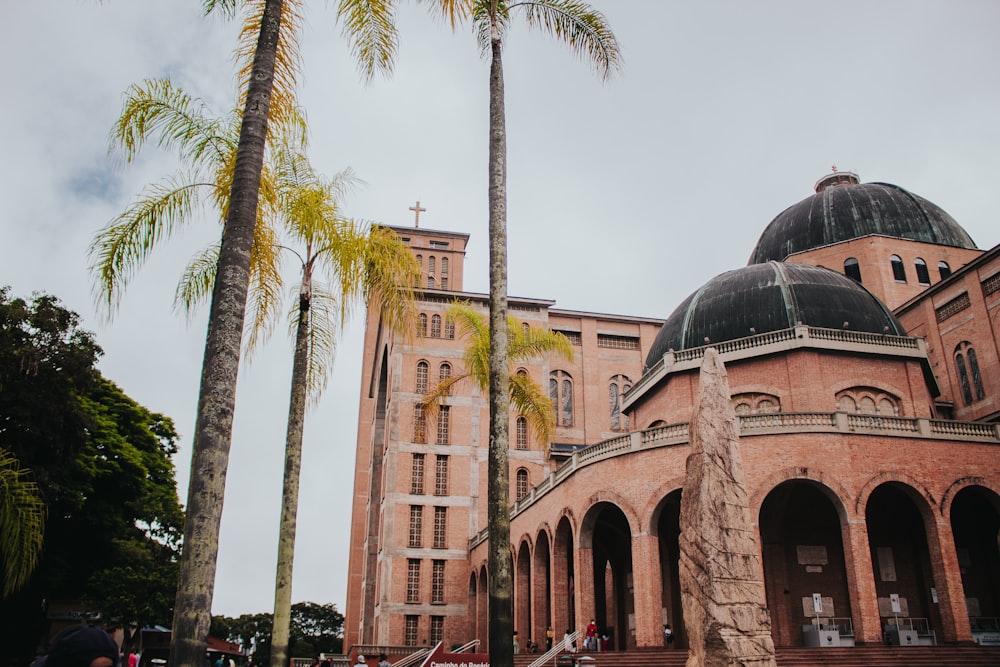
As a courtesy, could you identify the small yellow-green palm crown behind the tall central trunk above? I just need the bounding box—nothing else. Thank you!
[418,302,573,443]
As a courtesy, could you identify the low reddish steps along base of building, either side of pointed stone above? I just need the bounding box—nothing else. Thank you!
[514,645,1000,667]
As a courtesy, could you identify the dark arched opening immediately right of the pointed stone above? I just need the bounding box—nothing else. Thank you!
[759,480,853,646]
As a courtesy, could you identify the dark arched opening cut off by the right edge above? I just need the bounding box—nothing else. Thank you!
[951,486,1000,637]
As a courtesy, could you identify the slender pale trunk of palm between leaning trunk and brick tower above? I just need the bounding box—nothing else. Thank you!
[271,276,311,667]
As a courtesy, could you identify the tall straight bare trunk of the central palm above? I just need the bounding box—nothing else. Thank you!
[486,31,514,667]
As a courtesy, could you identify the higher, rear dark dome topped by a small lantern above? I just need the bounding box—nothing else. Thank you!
[749,172,976,264]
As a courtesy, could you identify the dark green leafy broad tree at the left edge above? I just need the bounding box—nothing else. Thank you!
[0,289,183,664]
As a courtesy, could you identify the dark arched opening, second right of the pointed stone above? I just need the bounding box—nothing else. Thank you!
[865,482,941,643]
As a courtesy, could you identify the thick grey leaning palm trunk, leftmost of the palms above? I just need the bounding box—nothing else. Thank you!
[170,0,283,667]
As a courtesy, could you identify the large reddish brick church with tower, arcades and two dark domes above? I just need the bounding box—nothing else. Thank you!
[345,172,1000,650]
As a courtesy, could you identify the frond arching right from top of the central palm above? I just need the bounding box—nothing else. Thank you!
[510,0,621,81]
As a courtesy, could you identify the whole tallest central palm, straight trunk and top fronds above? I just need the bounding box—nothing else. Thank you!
[454,0,620,667]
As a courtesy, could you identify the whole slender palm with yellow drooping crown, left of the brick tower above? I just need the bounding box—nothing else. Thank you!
[262,149,420,667]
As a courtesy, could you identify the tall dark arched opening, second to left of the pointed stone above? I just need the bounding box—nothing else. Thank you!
[587,503,635,651]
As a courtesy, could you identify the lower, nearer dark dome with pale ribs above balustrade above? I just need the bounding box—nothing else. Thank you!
[646,262,906,368]
